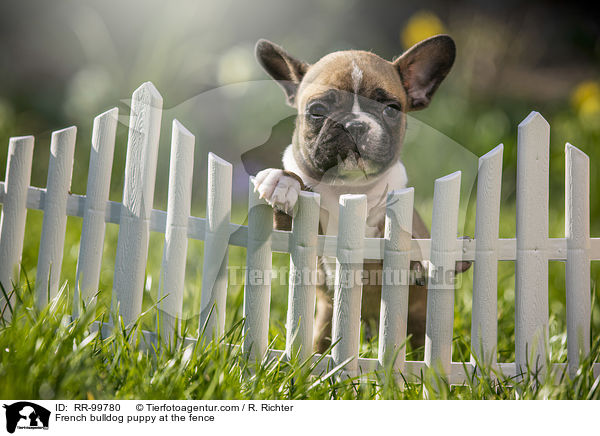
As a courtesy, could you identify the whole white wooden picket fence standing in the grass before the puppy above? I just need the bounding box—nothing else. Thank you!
[0,82,600,384]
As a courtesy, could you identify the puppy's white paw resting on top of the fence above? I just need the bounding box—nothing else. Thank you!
[253,168,302,216]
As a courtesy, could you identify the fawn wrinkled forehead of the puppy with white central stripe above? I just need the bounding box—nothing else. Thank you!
[298,51,406,107]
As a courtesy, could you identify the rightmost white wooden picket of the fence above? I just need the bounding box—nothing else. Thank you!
[565,143,591,377]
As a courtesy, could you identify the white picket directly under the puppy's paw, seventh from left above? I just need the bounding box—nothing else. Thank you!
[242,177,273,361]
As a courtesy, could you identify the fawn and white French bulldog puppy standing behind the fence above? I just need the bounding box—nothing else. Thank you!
[254,35,468,352]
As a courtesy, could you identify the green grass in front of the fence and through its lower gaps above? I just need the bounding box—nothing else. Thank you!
[0,200,600,399]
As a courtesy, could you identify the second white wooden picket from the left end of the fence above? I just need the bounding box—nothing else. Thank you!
[35,127,77,309]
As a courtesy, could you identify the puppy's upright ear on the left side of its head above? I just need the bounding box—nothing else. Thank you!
[255,39,309,106]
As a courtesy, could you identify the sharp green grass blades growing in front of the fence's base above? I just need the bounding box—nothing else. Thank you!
[0,266,600,399]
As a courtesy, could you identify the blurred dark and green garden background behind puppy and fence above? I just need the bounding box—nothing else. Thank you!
[0,0,600,358]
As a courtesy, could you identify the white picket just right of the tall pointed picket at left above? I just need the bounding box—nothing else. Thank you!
[157,120,195,342]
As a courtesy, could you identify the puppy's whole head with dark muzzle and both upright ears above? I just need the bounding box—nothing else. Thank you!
[256,35,456,183]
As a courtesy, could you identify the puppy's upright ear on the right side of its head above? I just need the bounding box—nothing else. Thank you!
[394,35,456,110]
